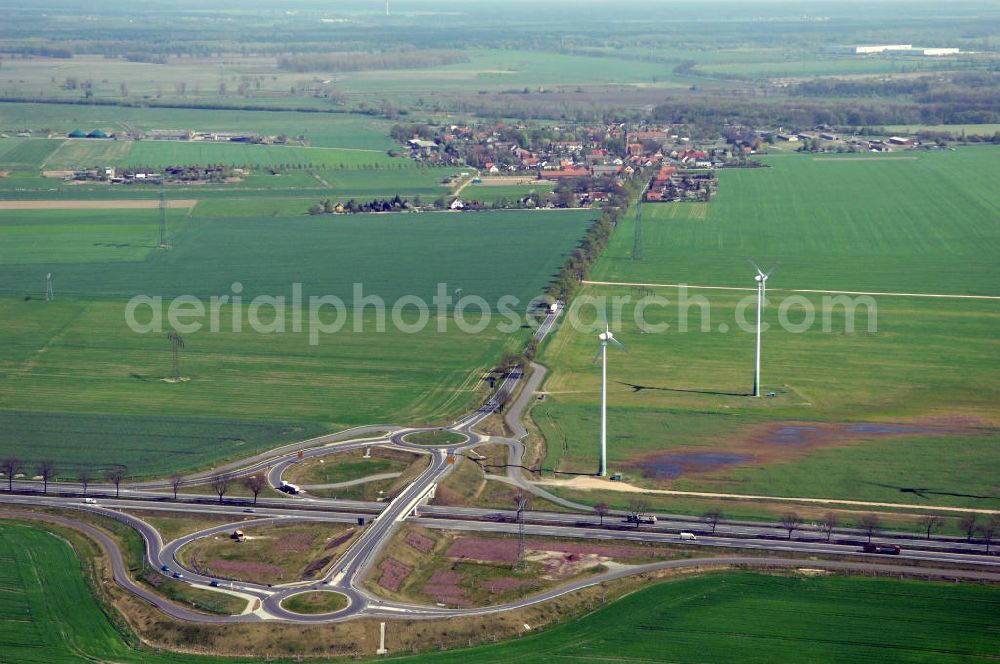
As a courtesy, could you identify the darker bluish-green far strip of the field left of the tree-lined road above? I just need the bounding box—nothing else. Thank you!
[0,210,593,303]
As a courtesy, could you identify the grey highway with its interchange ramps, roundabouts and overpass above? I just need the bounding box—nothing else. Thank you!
[0,309,1000,623]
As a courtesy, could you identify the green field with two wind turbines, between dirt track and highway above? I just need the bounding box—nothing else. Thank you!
[534,287,1000,507]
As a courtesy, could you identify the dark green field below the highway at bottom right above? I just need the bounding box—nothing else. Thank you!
[400,573,1000,663]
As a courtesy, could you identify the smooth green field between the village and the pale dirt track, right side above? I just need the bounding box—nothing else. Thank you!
[590,146,1000,295]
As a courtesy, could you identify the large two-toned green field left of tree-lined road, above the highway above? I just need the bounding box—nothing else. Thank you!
[0,210,590,476]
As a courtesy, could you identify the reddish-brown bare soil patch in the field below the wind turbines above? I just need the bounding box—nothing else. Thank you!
[632,418,981,480]
